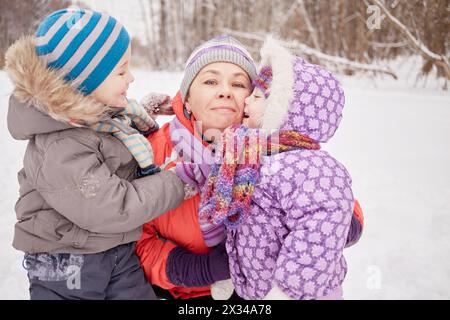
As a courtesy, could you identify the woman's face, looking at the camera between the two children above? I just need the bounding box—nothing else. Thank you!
[186,62,252,137]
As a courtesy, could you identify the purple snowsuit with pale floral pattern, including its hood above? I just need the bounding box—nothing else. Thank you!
[227,44,354,299]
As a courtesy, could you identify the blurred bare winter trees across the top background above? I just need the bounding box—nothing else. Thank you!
[0,0,450,84]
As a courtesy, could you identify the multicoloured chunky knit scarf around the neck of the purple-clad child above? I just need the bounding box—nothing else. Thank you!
[199,125,320,229]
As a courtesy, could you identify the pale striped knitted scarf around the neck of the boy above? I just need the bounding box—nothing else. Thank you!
[90,100,159,174]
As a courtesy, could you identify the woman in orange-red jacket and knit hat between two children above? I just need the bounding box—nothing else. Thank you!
[136,36,256,299]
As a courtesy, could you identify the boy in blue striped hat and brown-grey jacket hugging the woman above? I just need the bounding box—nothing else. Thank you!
[6,8,184,299]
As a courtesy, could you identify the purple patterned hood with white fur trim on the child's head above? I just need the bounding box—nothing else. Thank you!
[260,38,345,142]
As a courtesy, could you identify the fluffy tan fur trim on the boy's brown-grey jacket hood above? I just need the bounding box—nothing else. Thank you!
[5,36,110,126]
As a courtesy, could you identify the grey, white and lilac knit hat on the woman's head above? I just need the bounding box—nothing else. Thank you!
[180,35,256,101]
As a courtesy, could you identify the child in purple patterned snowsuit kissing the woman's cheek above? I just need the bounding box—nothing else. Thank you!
[200,40,355,300]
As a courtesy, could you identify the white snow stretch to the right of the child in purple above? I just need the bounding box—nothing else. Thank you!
[327,75,450,299]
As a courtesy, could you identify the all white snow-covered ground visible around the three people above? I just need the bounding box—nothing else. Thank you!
[0,65,450,299]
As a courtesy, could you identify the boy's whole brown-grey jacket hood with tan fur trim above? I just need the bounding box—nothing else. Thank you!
[5,36,110,139]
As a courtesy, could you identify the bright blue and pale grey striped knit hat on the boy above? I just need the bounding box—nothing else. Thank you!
[35,8,130,95]
